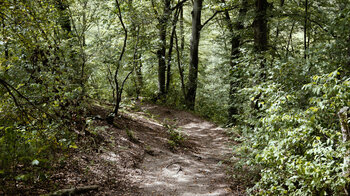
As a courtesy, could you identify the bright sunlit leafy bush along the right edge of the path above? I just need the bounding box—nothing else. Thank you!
[238,70,350,195]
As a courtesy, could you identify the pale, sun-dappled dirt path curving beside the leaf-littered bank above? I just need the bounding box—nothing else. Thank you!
[129,105,239,196]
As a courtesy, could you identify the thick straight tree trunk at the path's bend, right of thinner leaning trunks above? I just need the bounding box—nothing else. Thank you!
[185,0,203,110]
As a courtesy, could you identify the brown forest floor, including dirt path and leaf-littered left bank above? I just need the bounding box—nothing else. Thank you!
[4,100,245,196]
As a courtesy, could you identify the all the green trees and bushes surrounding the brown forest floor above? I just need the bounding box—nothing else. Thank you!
[0,0,350,195]
